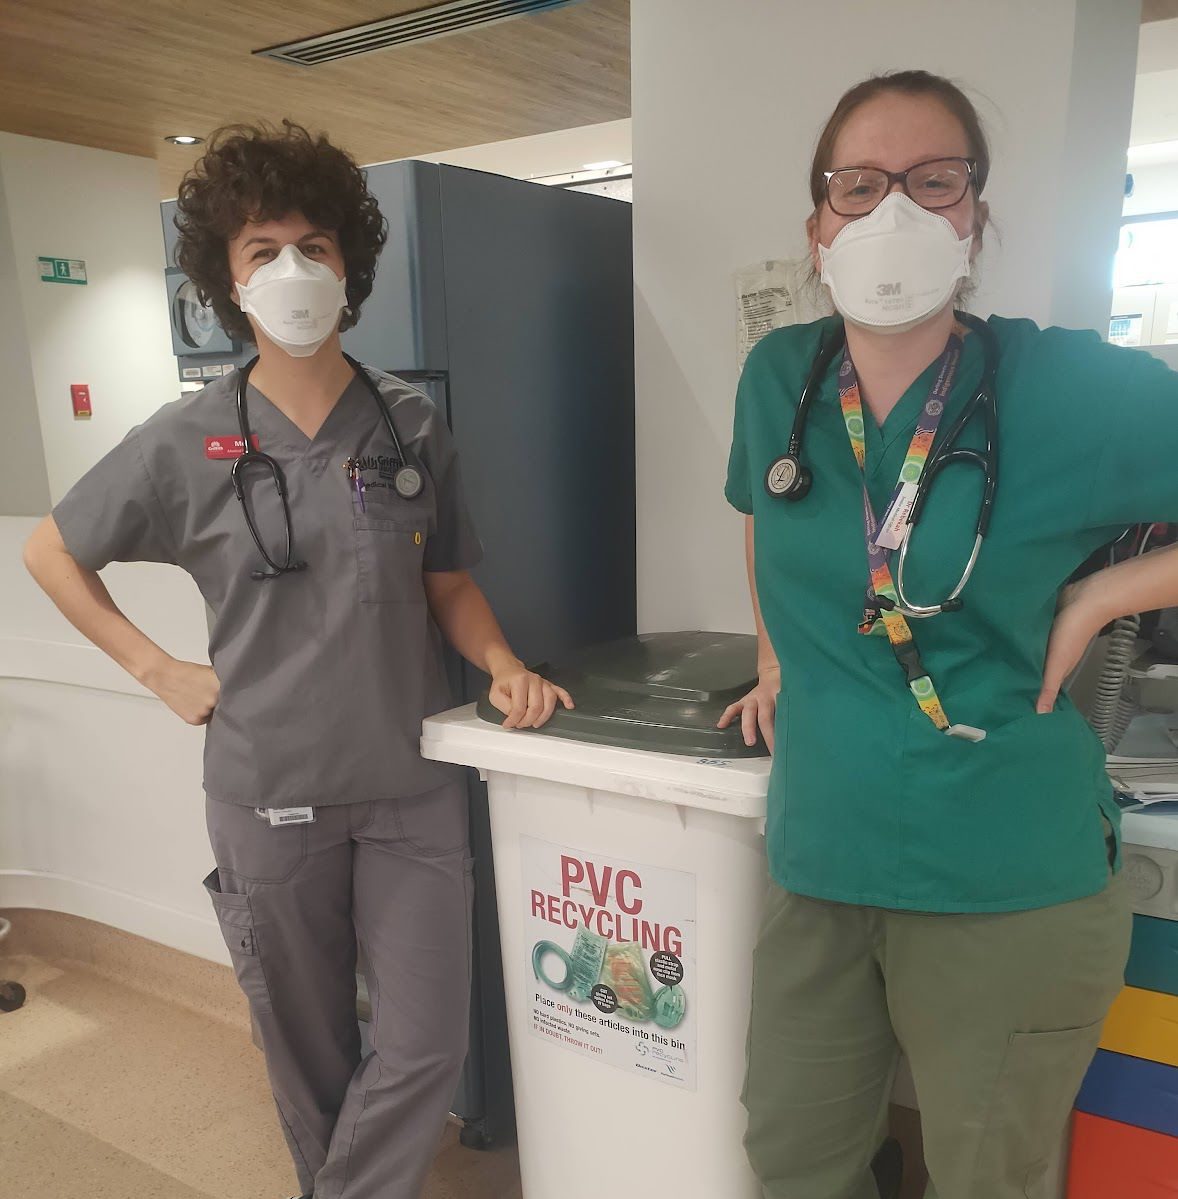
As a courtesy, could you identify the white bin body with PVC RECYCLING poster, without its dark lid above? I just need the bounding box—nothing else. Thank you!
[422,642,769,1199]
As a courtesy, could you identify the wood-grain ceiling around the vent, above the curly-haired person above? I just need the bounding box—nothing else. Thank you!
[0,0,630,197]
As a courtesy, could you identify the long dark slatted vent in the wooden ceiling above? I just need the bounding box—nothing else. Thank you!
[260,0,587,67]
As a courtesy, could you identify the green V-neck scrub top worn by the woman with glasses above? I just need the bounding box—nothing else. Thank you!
[726,318,1178,912]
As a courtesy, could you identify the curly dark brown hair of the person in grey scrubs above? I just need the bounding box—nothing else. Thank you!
[175,120,389,342]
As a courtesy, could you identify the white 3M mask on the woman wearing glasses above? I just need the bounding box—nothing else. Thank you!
[818,192,973,333]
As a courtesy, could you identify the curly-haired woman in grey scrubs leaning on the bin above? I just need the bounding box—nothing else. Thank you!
[25,122,571,1199]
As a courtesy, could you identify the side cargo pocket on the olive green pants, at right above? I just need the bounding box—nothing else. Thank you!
[981,1019,1104,1199]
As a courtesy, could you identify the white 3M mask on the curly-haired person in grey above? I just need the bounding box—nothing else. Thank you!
[238,245,348,359]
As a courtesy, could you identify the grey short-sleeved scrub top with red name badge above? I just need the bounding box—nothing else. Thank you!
[53,370,482,807]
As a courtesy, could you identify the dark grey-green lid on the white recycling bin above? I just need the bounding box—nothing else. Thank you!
[479,632,769,758]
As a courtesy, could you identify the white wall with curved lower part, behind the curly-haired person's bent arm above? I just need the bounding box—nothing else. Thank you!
[0,133,217,960]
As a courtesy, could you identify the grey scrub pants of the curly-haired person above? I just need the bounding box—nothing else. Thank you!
[205,784,473,1199]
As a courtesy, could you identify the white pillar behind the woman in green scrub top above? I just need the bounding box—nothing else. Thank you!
[631,0,1138,629]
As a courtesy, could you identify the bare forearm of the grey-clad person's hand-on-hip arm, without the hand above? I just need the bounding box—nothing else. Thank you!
[24,517,168,683]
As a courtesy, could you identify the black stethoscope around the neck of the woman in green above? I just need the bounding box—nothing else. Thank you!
[765,312,998,619]
